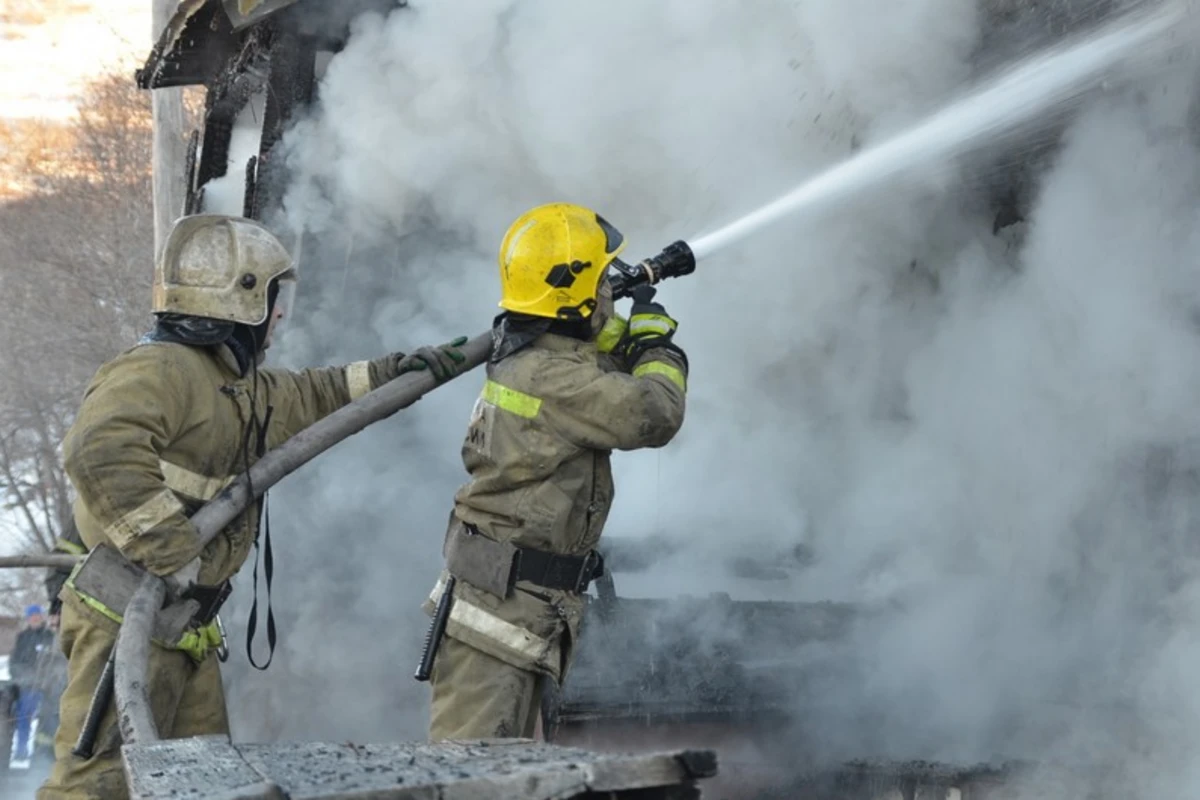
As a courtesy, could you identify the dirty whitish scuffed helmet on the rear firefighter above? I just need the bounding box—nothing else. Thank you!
[151,213,294,325]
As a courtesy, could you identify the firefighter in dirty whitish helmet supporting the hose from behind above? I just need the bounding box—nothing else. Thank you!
[37,215,464,800]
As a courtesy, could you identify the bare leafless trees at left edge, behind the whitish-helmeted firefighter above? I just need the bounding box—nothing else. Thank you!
[0,72,154,609]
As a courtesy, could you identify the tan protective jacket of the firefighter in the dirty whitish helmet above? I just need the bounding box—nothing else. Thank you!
[64,342,398,585]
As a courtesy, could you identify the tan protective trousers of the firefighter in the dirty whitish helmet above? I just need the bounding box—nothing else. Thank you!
[37,589,229,800]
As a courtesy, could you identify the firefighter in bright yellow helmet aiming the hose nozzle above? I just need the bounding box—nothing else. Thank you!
[425,203,688,741]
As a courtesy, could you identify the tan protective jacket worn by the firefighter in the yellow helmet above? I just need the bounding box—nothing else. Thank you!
[425,333,686,680]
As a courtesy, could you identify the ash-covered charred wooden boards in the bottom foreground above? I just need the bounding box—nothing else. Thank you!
[122,736,716,800]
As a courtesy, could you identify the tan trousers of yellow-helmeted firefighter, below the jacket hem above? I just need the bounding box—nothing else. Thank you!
[430,636,546,741]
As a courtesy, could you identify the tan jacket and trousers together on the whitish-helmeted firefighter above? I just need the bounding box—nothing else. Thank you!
[38,339,400,800]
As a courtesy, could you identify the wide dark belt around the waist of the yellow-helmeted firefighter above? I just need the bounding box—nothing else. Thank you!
[443,516,604,597]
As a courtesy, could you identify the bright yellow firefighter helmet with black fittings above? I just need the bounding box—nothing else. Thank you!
[499,203,625,319]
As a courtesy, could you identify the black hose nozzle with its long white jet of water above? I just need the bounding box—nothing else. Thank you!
[610,0,1190,292]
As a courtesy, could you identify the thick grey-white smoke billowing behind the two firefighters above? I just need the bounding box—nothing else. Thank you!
[211,0,1200,796]
